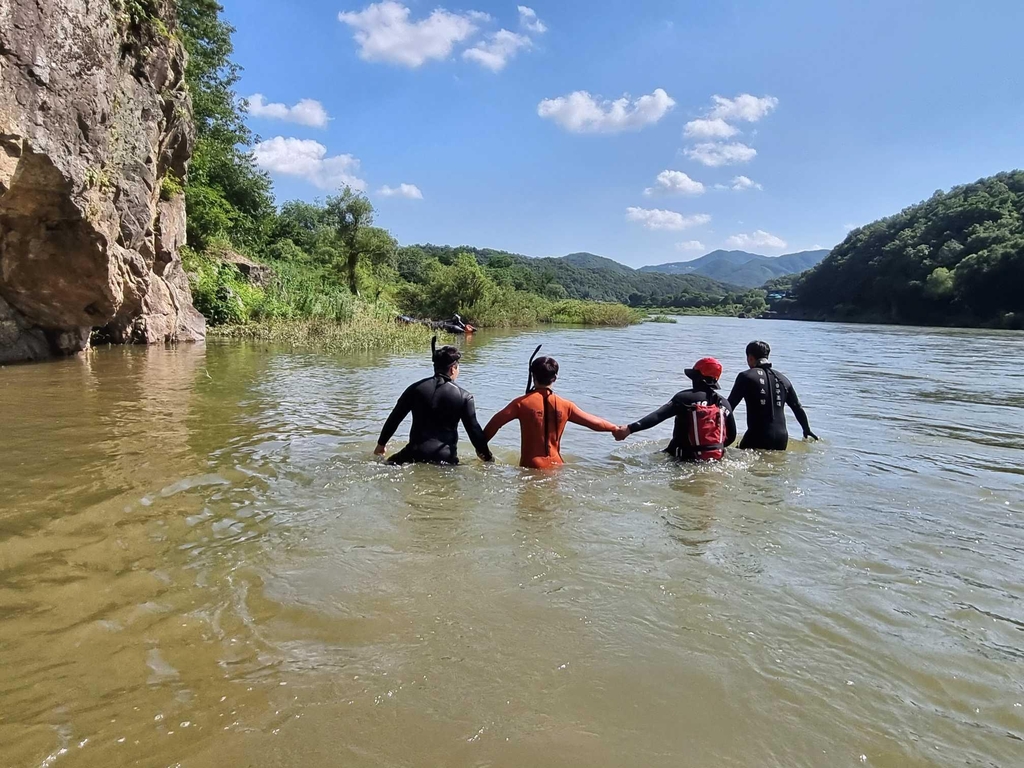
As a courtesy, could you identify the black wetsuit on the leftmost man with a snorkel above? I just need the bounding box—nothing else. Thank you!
[378,374,490,464]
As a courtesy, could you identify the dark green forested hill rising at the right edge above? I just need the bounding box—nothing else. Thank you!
[791,171,1024,328]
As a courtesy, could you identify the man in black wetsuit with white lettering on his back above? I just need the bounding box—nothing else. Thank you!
[729,341,818,451]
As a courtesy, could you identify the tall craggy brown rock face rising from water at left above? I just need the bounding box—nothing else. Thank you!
[0,0,206,362]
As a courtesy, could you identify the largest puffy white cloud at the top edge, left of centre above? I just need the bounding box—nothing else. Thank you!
[338,0,477,68]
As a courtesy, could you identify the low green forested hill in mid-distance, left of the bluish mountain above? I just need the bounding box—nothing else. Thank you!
[399,245,757,307]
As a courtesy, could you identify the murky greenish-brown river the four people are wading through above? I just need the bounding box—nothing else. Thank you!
[0,318,1024,768]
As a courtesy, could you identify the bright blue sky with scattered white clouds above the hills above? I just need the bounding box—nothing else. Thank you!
[222,0,1024,266]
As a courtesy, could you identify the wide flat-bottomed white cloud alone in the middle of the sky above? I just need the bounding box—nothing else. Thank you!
[537,88,676,133]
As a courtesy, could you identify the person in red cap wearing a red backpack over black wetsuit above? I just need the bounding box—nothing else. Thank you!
[614,357,736,461]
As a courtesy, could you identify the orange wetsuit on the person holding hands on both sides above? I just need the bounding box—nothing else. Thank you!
[483,387,615,469]
